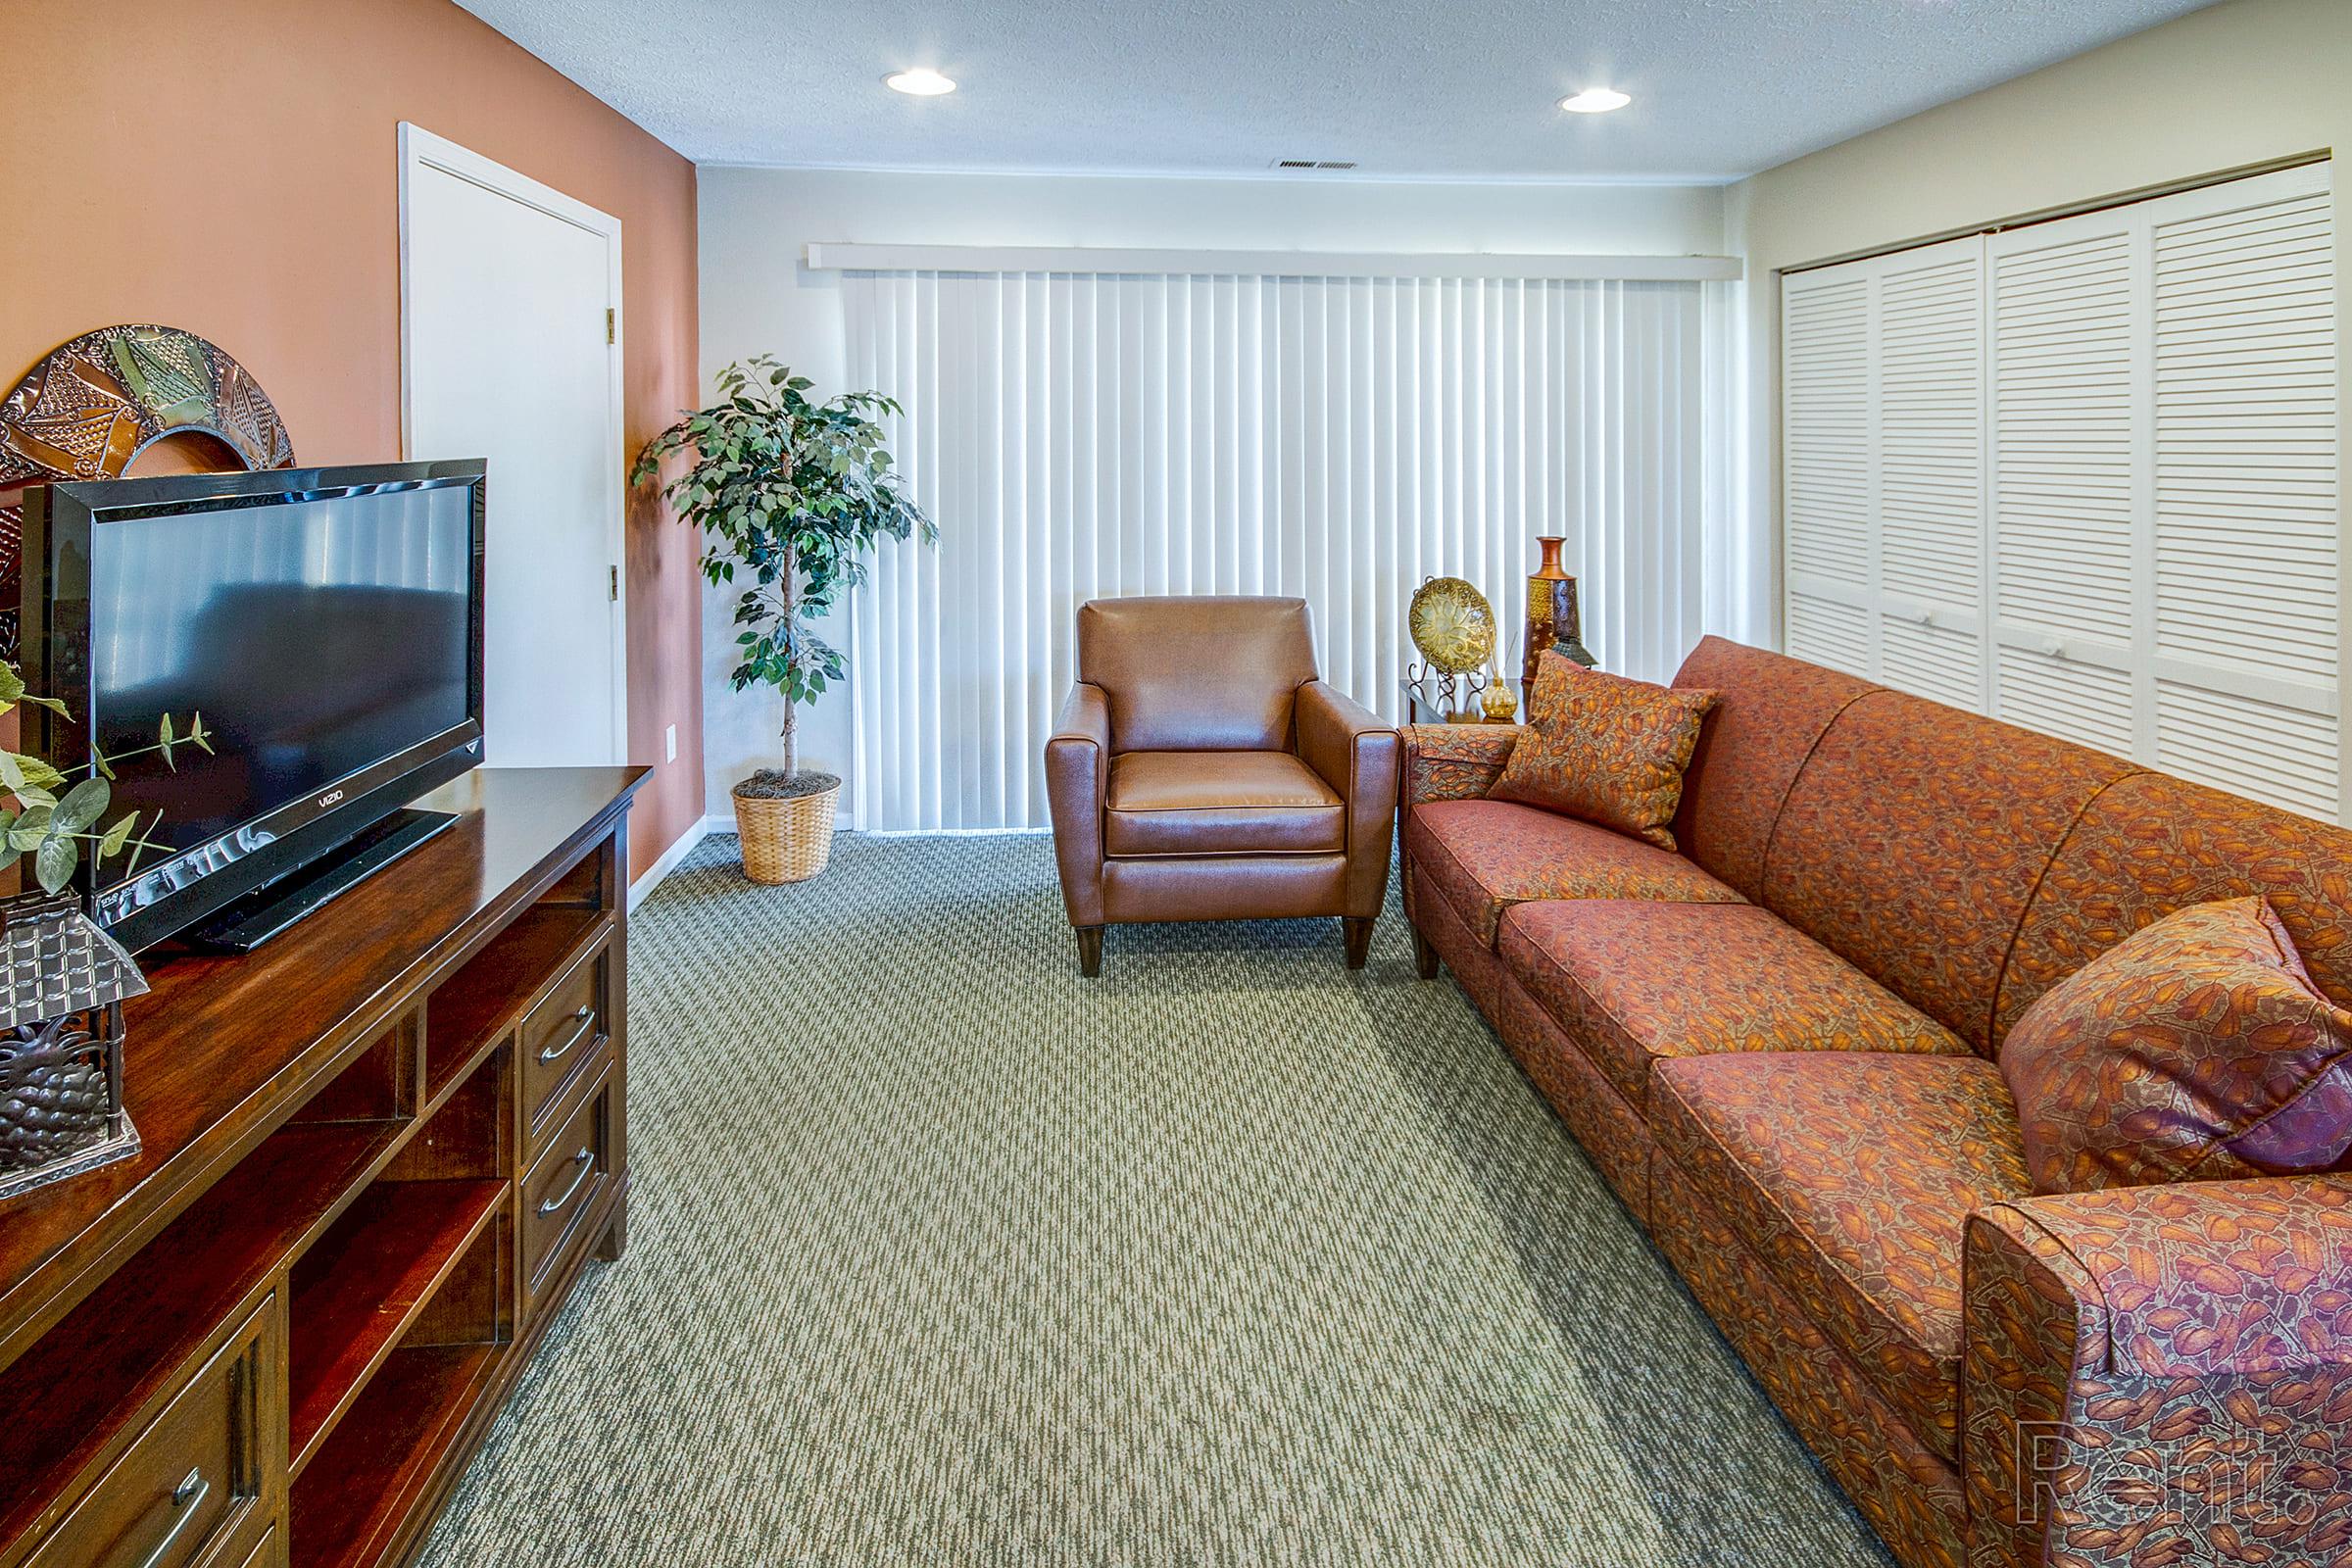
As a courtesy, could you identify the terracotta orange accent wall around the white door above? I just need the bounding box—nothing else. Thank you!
[0,0,704,870]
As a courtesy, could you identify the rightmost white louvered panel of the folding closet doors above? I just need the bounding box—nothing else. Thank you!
[2140,176,2352,820]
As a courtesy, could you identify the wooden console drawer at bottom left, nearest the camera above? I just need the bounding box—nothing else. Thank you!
[25,1296,282,1568]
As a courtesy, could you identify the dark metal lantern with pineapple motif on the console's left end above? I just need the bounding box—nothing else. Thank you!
[0,894,148,1199]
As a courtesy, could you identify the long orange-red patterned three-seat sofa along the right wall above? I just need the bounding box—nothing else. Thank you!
[1401,637,2352,1568]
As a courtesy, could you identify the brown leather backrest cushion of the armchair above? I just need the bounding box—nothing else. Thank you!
[1077,595,1315,753]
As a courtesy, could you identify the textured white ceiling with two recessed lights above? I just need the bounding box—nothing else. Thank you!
[459,0,2211,178]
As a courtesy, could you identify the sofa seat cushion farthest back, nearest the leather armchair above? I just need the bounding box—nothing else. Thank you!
[1404,800,1740,948]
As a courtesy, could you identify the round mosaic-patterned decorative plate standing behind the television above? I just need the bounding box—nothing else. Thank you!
[0,326,294,662]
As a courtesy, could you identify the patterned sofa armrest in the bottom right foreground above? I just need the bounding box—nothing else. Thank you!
[1962,1175,2352,1568]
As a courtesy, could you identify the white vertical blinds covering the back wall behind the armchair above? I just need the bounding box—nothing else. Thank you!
[842,272,1739,830]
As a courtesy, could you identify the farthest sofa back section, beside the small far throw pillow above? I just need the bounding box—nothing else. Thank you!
[1675,637,1880,901]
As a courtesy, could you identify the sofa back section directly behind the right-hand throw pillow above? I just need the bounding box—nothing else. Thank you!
[1994,773,2352,1037]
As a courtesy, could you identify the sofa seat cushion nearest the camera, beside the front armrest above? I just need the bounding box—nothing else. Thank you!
[1648,1051,2033,1462]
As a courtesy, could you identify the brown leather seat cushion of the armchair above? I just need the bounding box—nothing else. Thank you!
[1103,753,1348,856]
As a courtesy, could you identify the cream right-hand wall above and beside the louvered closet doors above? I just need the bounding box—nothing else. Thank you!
[1724,0,2352,649]
